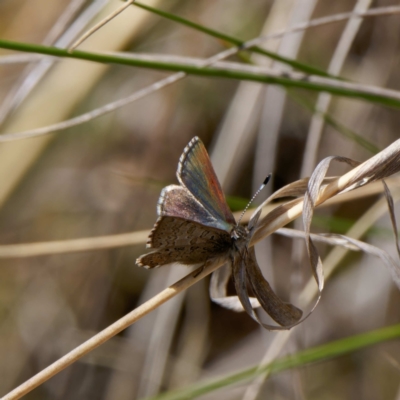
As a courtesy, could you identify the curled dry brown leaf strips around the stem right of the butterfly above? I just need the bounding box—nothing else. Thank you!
[214,141,400,330]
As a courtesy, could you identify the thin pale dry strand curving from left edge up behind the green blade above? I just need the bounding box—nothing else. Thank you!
[0,4,400,142]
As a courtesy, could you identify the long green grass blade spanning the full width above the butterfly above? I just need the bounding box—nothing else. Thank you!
[0,40,400,108]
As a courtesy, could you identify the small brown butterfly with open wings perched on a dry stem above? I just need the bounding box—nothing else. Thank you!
[137,137,248,268]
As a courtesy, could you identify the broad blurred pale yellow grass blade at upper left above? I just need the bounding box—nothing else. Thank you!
[0,0,161,212]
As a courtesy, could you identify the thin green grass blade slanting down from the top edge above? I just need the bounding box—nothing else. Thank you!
[132,2,339,79]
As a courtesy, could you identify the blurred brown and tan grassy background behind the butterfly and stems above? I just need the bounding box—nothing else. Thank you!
[0,0,400,400]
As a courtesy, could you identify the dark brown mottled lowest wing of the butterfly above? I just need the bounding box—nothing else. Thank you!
[137,216,231,268]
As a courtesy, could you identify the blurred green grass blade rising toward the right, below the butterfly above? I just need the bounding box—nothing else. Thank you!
[146,324,400,400]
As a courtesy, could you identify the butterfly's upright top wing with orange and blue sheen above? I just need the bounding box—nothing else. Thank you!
[177,137,236,229]
